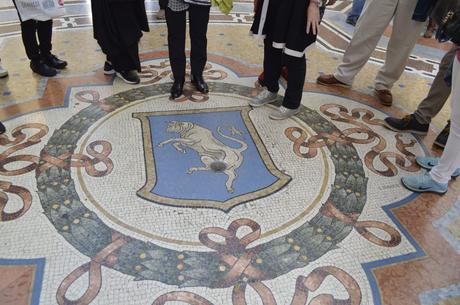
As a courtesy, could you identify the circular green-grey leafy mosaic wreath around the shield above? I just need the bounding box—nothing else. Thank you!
[36,83,367,288]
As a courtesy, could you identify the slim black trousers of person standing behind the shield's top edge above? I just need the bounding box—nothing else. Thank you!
[166,4,210,80]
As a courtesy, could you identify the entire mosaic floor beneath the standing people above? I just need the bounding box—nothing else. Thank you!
[0,0,460,305]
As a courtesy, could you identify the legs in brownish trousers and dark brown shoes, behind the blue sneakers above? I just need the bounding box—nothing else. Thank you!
[385,47,456,148]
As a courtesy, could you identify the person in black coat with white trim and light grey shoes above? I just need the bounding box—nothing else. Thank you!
[249,0,324,120]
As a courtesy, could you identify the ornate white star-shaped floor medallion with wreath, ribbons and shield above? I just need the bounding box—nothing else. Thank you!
[0,54,458,305]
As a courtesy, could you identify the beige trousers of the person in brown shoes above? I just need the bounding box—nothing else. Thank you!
[334,0,424,90]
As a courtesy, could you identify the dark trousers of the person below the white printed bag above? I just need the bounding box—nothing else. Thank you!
[21,20,53,60]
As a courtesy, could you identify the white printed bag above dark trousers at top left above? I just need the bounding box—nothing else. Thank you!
[15,0,66,21]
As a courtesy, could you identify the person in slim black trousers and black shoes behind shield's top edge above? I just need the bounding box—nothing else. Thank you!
[166,0,211,99]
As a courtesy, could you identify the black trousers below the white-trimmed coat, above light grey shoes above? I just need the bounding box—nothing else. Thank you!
[263,39,307,109]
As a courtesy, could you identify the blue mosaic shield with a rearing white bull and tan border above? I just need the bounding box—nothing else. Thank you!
[133,107,291,211]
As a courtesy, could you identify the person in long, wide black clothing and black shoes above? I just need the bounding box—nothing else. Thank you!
[91,0,149,84]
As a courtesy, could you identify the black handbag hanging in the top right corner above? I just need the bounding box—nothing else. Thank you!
[431,0,460,45]
